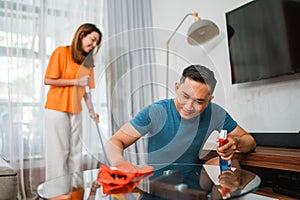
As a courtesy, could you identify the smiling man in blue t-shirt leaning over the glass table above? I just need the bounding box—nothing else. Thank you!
[106,65,256,173]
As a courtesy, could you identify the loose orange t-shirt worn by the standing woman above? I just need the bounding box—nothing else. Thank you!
[45,46,95,114]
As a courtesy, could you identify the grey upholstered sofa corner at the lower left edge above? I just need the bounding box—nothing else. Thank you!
[0,156,18,200]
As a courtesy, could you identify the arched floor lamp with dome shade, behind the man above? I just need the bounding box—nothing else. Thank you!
[166,12,220,98]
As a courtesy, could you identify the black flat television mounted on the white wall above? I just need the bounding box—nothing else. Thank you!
[226,0,300,84]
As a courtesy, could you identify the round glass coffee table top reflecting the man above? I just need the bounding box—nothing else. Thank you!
[37,163,261,200]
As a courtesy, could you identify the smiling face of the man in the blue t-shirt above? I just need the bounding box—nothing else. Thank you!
[175,78,213,119]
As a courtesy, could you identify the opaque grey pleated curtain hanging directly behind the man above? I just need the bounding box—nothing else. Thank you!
[104,0,158,164]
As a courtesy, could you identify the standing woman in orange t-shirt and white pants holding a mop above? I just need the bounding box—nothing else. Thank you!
[44,23,102,180]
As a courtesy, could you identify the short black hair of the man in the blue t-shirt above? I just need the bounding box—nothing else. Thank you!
[180,65,217,95]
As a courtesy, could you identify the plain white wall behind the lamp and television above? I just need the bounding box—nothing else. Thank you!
[152,0,300,132]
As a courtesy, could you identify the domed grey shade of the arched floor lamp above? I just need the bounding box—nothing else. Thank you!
[187,19,220,45]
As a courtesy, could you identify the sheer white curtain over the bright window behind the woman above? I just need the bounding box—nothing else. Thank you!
[0,0,103,199]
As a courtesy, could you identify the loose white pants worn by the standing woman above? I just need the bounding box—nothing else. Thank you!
[45,109,82,180]
